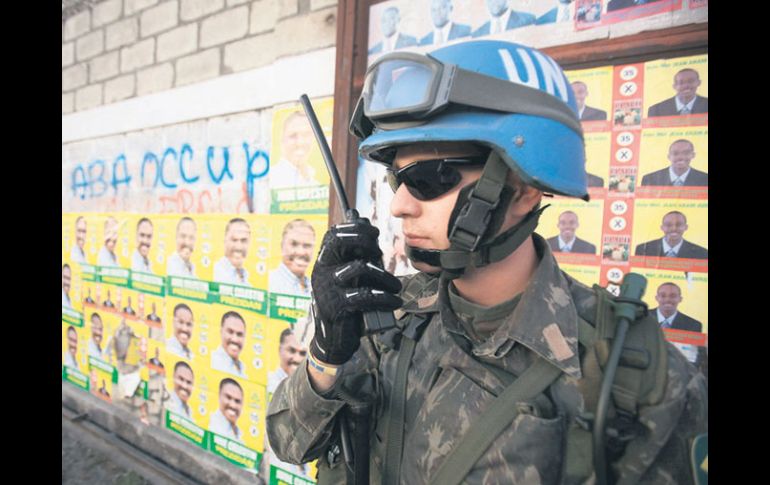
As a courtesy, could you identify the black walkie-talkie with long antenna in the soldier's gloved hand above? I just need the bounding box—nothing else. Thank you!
[299,94,396,335]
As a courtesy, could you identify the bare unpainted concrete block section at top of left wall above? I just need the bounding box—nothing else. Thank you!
[62,0,337,114]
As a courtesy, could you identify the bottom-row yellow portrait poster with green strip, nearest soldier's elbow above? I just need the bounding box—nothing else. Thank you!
[204,370,267,473]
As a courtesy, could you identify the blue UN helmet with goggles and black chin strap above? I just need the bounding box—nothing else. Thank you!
[350,41,588,276]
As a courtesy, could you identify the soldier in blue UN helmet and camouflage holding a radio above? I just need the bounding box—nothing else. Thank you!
[267,41,707,484]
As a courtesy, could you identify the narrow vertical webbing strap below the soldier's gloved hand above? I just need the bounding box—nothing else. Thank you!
[382,334,417,485]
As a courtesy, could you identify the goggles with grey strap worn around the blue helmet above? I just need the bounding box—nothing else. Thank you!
[350,52,583,139]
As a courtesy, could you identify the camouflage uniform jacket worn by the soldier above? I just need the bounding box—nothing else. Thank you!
[267,234,708,485]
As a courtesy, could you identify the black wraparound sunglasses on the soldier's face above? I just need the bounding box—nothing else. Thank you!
[387,155,487,200]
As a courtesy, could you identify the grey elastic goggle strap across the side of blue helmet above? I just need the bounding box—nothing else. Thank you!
[449,68,583,138]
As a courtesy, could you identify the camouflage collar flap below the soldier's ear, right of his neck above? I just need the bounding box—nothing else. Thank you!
[441,233,581,378]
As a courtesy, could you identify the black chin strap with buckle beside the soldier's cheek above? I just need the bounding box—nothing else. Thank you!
[442,150,509,251]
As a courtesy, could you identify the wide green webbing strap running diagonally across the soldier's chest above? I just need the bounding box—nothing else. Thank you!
[430,357,561,485]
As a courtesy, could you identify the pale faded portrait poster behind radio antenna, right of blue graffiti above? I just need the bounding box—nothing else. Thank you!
[268,97,334,214]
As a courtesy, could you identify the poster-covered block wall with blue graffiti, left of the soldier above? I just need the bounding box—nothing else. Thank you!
[61,0,336,483]
